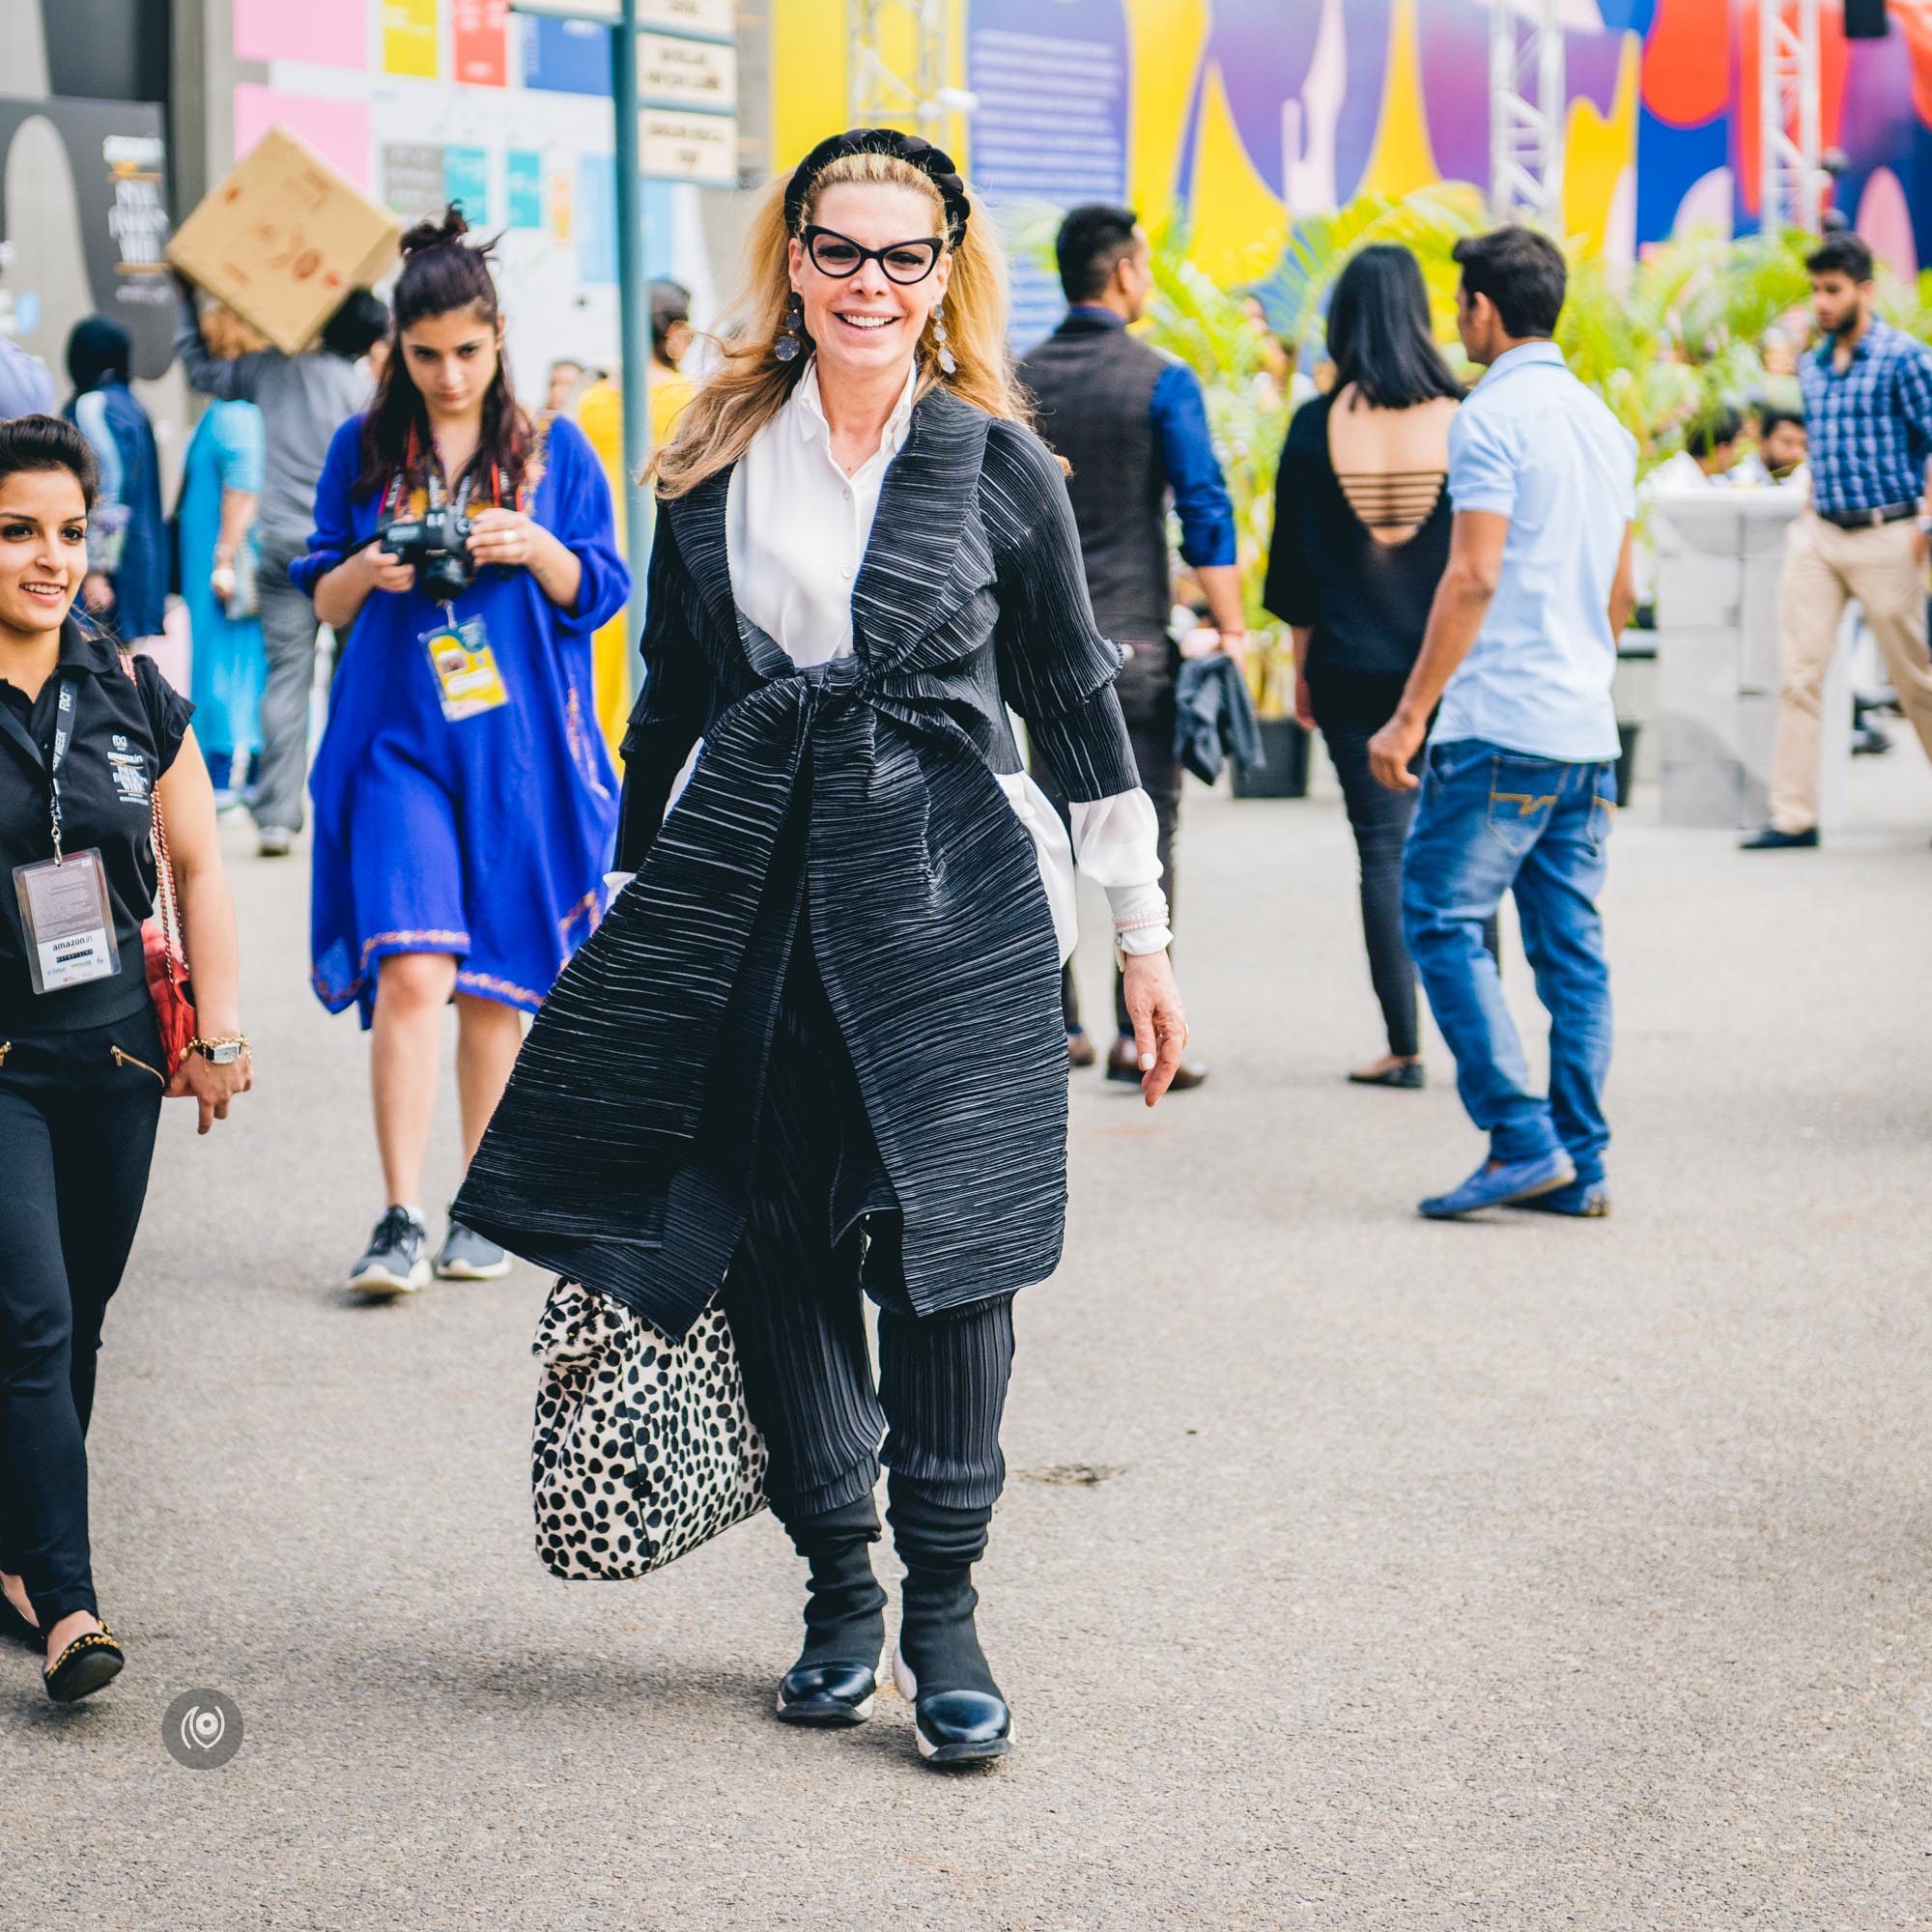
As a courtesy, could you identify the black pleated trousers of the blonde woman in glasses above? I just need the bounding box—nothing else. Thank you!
[724,943,1012,1526]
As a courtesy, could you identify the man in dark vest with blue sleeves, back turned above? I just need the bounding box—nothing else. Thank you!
[1020,205,1246,1092]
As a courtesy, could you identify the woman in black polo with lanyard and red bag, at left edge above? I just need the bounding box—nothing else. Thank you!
[0,415,249,1704]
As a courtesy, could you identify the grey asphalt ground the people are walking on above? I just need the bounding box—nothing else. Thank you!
[0,732,1932,1932]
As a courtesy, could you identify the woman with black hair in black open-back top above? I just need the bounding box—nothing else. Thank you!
[1264,243,1463,1088]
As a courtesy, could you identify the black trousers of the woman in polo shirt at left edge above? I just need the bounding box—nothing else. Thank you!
[0,1007,162,1629]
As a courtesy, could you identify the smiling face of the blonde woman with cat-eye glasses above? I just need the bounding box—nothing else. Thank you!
[790,182,952,377]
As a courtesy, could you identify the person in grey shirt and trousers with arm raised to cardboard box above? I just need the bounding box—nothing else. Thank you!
[174,280,388,858]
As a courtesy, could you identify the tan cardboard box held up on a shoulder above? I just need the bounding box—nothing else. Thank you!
[168,128,402,355]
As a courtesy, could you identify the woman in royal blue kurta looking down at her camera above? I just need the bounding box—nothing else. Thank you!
[290,209,630,1294]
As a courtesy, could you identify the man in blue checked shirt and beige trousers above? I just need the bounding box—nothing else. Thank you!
[1745,232,1932,852]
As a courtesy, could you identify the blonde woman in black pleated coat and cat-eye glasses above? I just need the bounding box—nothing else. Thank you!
[458,128,1186,1766]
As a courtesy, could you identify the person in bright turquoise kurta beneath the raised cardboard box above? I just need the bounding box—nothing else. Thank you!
[180,388,269,804]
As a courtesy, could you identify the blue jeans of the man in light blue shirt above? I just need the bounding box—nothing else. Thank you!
[1403,738,1617,1180]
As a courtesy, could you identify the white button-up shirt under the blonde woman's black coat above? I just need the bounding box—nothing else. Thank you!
[724,357,1171,960]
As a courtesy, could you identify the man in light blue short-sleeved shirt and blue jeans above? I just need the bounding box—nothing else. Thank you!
[1370,228,1636,1219]
